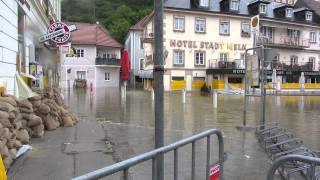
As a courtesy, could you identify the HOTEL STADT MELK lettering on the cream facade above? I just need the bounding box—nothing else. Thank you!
[170,40,247,51]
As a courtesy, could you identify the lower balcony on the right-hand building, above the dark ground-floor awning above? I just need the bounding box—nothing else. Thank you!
[271,62,316,71]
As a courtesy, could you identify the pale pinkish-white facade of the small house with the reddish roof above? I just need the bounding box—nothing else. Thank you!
[60,45,121,88]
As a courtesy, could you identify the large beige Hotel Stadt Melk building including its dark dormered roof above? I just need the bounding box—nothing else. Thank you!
[143,0,320,91]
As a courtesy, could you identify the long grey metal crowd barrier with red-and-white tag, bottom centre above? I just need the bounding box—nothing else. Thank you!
[72,129,224,180]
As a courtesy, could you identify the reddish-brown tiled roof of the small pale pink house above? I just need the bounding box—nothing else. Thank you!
[67,22,122,48]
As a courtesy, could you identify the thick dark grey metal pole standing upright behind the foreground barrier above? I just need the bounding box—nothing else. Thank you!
[153,0,164,180]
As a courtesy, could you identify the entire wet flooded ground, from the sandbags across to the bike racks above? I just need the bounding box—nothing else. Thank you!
[9,89,320,180]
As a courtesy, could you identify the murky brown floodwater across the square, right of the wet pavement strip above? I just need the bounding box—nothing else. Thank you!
[65,89,320,180]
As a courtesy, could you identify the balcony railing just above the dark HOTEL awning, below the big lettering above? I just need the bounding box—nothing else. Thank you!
[209,59,244,69]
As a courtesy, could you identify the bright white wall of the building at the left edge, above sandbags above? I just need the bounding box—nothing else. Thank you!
[0,0,18,94]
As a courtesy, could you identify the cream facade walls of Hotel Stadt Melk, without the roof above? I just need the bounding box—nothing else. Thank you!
[144,4,320,91]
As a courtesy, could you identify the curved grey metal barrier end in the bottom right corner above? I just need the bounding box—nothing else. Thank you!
[267,154,320,180]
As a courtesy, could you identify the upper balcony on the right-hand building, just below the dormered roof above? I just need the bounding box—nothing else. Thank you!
[257,36,310,49]
